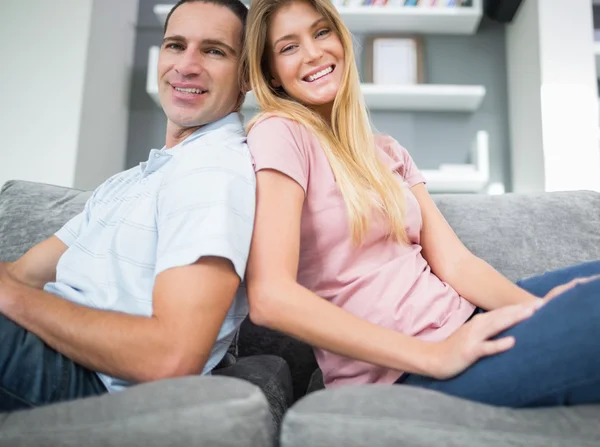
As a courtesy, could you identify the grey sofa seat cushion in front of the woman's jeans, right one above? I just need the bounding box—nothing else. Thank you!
[280,385,600,447]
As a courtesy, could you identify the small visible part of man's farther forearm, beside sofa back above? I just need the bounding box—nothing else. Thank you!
[6,236,67,289]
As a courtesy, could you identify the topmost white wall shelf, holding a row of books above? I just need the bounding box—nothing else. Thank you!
[154,0,483,34]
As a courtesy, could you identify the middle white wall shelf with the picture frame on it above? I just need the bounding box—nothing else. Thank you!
[146,46,485,112]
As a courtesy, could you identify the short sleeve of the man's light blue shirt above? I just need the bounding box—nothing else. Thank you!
[155,146,256,281]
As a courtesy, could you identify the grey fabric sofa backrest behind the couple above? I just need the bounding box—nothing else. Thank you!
[0,181,600,398]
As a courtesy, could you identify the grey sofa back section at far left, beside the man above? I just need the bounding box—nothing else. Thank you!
[0,180,91,262]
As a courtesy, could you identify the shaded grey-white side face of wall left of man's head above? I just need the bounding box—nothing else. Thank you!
[74,0,138,189]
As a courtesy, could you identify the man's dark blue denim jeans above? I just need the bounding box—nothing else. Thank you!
[0,315,107,412]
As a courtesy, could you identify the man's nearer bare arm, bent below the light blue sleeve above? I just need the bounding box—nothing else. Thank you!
[0,257,240,382]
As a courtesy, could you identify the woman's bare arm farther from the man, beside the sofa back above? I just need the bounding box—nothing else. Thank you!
[411,183,538,310]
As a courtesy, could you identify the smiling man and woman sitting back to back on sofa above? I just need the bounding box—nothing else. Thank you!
[0,0,600,411]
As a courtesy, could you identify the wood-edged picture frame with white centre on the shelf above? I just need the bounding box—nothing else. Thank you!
[365,34,425,85]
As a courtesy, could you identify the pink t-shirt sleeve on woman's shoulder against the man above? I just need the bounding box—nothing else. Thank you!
[248,117,309,193]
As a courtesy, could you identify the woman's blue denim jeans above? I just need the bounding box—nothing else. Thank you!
[397,261,600,408]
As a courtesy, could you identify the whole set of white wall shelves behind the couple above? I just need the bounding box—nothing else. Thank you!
[146,0,490,193]
